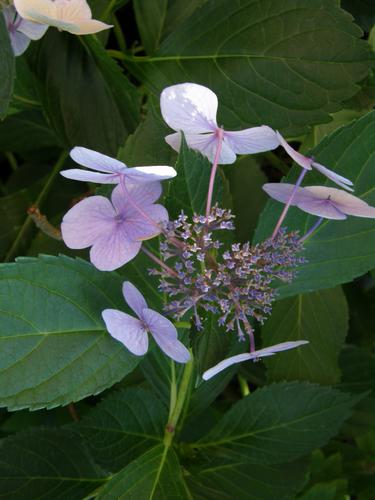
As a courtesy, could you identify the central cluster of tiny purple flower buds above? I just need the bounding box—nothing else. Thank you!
[151,206,305,337]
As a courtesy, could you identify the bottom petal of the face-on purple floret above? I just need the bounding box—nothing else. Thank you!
[90,229,142,271]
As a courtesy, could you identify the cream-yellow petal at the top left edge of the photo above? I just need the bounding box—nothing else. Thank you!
[14,0,112,35]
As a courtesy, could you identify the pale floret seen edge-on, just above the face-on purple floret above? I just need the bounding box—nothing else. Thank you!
[61,146,177,184]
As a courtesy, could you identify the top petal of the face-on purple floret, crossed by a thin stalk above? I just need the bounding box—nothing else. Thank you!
[111,181,162,214]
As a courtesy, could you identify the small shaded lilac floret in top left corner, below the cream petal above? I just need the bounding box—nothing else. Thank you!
[3,6,48,56]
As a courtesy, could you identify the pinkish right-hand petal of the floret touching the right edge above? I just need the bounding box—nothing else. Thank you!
[306,186,375,218]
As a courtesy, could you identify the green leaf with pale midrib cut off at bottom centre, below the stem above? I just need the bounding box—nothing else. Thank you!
[97,445,191,500]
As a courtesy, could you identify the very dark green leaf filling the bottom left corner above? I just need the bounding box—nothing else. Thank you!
[0,429,106,500]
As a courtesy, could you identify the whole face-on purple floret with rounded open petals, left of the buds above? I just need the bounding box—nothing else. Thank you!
[61,182,168,271]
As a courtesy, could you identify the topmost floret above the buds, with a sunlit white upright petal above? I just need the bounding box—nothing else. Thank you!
[160,83,279,164]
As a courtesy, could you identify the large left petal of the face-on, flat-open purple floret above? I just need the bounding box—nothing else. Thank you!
[61,196,116,249]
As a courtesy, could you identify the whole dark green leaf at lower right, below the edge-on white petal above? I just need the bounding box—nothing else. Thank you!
[195,382,360,464]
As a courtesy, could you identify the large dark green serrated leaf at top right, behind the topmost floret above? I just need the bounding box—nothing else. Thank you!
[125,0,375,132]
